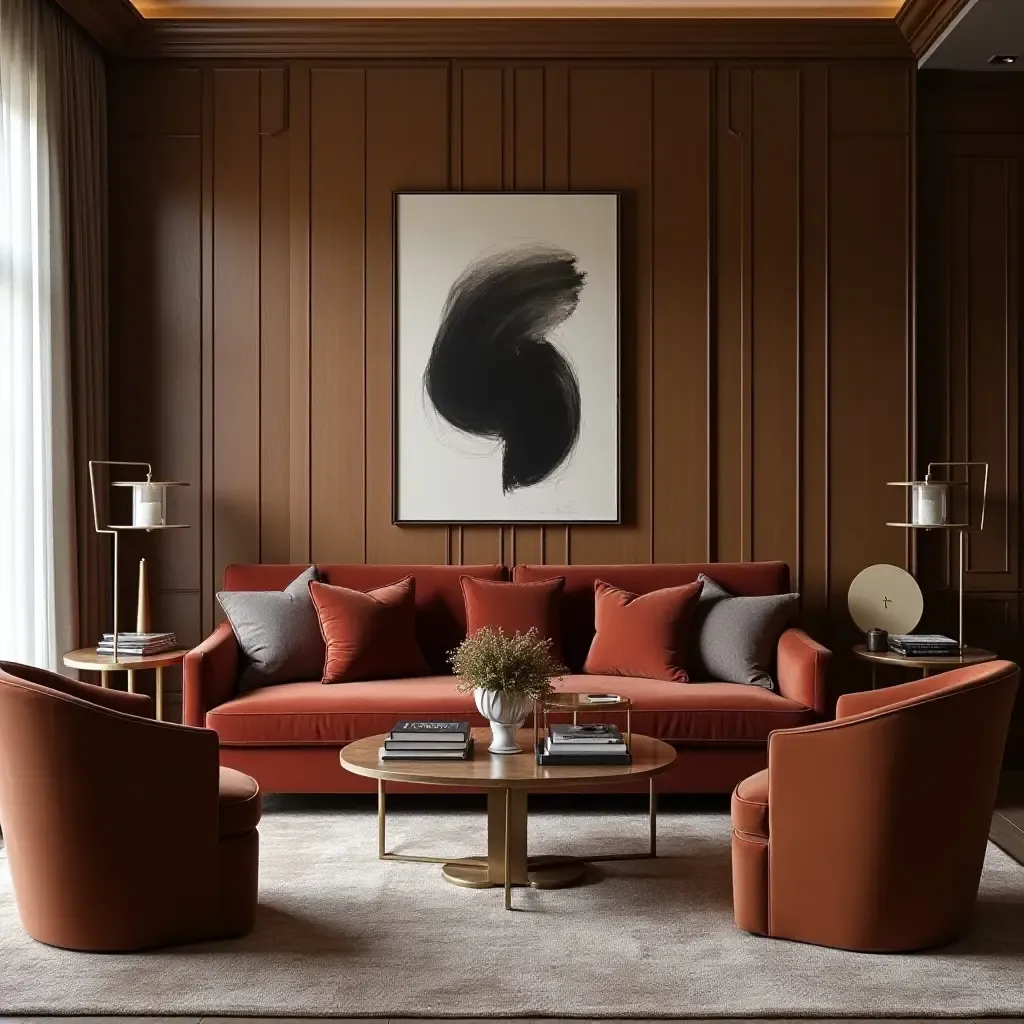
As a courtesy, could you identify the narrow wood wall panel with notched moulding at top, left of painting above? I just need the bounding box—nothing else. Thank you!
[259,69,291,562]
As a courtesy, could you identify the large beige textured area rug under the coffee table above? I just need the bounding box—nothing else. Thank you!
[0,798,1024,1018]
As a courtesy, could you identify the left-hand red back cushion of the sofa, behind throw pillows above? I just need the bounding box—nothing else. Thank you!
[224,563,509,678]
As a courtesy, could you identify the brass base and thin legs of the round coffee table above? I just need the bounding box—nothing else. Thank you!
[377,779,657,910]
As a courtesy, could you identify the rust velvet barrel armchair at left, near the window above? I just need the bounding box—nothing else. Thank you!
[0,662,261,952]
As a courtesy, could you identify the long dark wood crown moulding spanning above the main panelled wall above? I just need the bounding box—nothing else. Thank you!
[130,18,911,60]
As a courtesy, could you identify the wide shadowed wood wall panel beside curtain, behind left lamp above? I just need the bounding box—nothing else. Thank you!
[106,69,204,642]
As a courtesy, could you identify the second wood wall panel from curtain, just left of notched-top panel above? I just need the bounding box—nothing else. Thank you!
[209,69,260,593]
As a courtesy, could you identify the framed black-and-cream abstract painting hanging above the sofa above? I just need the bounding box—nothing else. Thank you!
[392,193,622,524]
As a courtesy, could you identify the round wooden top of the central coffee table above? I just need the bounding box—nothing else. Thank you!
[341,729,676,790]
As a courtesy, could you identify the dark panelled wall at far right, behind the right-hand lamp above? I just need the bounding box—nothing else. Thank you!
[918,73,1024,763]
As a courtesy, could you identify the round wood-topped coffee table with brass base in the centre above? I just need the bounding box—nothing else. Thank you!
[341,729,676,910]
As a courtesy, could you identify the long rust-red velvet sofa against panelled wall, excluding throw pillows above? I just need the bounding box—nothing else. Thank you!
[184,562,829,793]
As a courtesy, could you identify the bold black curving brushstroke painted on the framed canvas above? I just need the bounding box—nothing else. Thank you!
[423,247,587,495]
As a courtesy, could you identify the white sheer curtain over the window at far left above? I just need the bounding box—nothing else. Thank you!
[0,0,77,668]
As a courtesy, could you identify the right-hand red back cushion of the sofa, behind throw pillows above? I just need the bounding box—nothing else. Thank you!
[516,562,790,679]
